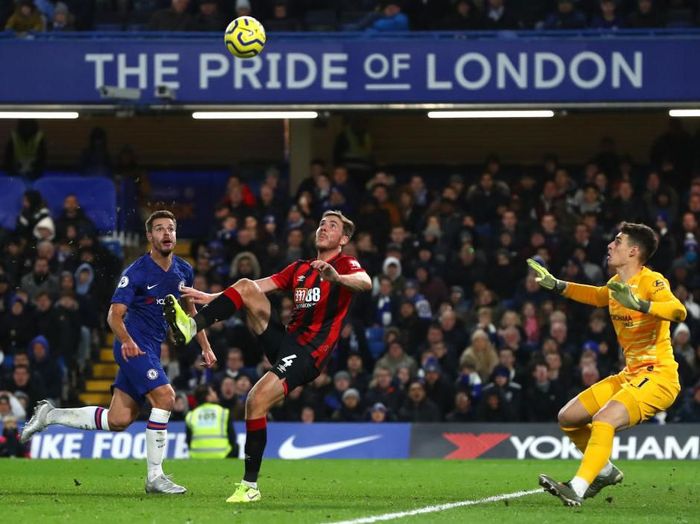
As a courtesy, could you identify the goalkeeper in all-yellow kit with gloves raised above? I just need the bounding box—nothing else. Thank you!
[527,222,686,506]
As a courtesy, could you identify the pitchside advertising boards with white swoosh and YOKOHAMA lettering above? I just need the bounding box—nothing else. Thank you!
[19,422,700,460]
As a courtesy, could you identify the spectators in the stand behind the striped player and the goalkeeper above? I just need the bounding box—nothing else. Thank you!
[178,116,700,422]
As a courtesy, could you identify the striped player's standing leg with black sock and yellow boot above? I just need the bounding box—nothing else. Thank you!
[226,372,285,503]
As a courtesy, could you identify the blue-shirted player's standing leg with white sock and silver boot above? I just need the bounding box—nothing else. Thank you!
[146,384,187,494]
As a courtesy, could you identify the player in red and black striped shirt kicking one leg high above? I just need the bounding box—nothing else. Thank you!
[164,211,372,502]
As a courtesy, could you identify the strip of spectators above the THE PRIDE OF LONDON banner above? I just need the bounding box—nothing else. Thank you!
[0,0,700,34]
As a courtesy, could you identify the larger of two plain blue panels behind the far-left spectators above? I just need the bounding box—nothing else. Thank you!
[34,176,117,233]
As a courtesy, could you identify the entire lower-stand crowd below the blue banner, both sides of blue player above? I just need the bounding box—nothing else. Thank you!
[0,114,700,430]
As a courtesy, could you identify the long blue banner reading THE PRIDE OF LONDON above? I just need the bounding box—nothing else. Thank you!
[0,33,700,105]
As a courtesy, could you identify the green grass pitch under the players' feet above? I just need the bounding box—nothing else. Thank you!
[0,459,700,524]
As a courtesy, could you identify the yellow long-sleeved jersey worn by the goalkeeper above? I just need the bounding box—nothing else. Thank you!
[564,267,686,382]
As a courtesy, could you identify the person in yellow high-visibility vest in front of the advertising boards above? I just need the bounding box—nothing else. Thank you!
[185,384,238,458]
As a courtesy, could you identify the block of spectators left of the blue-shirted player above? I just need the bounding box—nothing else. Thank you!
[0,179,122,434]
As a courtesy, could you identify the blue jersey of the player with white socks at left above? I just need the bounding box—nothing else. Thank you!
[112,254,194,348]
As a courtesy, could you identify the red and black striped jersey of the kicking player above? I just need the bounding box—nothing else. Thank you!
[271,253,364,369]
